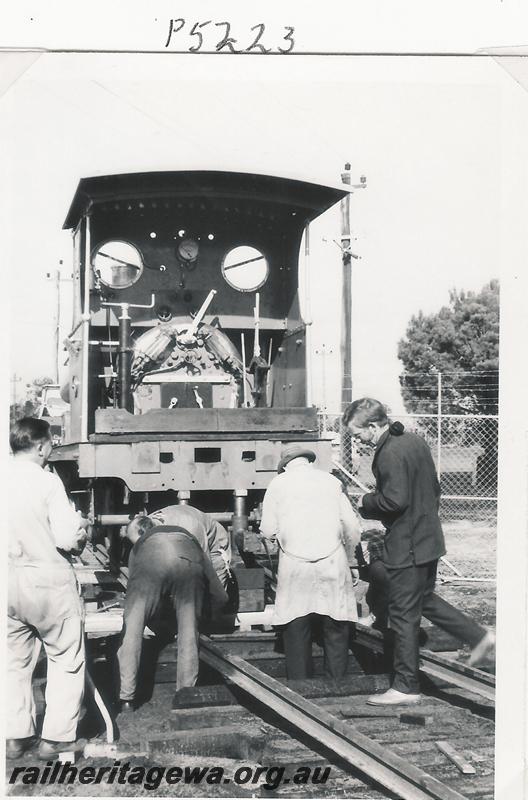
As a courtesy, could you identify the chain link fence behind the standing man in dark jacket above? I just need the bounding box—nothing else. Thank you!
[319,413,498,526]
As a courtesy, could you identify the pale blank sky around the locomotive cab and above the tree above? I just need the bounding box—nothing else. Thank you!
[0,53,511,412]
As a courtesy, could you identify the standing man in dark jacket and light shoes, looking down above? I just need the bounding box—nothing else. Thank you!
[343,398,493,705]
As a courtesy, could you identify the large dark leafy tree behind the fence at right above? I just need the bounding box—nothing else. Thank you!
[398,280,499,414]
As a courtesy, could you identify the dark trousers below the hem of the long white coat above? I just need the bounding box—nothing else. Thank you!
[283,614,350,680]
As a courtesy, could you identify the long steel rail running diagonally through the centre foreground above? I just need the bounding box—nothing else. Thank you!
[200,635,464,800]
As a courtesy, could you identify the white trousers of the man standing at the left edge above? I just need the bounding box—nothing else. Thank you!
[6,561,84,742]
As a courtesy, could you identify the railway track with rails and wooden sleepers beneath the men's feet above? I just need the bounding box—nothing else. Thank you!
[10,549,494,800]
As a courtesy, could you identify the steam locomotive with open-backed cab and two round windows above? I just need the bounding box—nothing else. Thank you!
[53,171,349,550]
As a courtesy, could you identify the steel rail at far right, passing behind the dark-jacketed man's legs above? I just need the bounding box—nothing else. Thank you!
[355,626,495,702]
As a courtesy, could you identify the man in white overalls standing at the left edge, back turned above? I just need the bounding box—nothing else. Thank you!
[6,417,88,760]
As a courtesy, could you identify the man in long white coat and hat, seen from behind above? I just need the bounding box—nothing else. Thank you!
[260,443,360,679]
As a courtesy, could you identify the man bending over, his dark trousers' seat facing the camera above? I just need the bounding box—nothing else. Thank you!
[117,517,227,709]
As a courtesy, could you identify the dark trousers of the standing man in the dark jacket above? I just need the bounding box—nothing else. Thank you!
[386,561,486,694]
